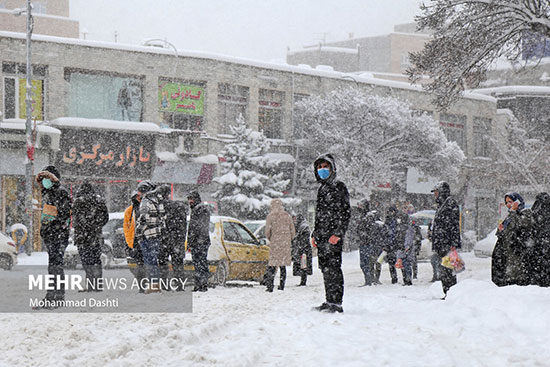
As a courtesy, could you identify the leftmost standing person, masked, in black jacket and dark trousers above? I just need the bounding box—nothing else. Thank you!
[36,166,71,308]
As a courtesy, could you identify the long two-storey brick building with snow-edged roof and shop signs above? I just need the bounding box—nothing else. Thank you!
[0,32,508,239]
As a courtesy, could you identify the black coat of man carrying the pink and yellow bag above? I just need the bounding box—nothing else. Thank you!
[431,196,462,257]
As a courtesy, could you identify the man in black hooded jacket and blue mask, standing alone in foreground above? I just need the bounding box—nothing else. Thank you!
[312,154,350,312]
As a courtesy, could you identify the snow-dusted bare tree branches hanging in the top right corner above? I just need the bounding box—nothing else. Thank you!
[407,0,550,110]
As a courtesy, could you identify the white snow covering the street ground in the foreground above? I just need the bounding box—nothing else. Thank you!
[0,252,550,367]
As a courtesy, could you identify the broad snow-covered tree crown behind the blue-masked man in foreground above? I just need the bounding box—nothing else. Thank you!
[297,88,464,194]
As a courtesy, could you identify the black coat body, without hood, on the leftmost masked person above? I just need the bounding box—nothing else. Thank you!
[40,182,72,242]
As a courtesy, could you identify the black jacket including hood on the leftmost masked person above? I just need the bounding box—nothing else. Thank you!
[36,166,72,242]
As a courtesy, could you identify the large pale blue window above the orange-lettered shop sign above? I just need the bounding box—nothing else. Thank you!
[65,70,143,121]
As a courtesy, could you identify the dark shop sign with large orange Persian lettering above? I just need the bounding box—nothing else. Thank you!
[57,129,156,179]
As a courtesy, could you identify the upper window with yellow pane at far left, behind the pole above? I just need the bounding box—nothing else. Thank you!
[2,62,47,120]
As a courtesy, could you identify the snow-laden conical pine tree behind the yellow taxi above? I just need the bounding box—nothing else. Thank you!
[213,116,295,219]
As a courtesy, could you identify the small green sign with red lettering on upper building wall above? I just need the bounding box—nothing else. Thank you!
[159,82,204,116]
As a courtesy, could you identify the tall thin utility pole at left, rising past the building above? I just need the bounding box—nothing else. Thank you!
[25,0,34,255]
